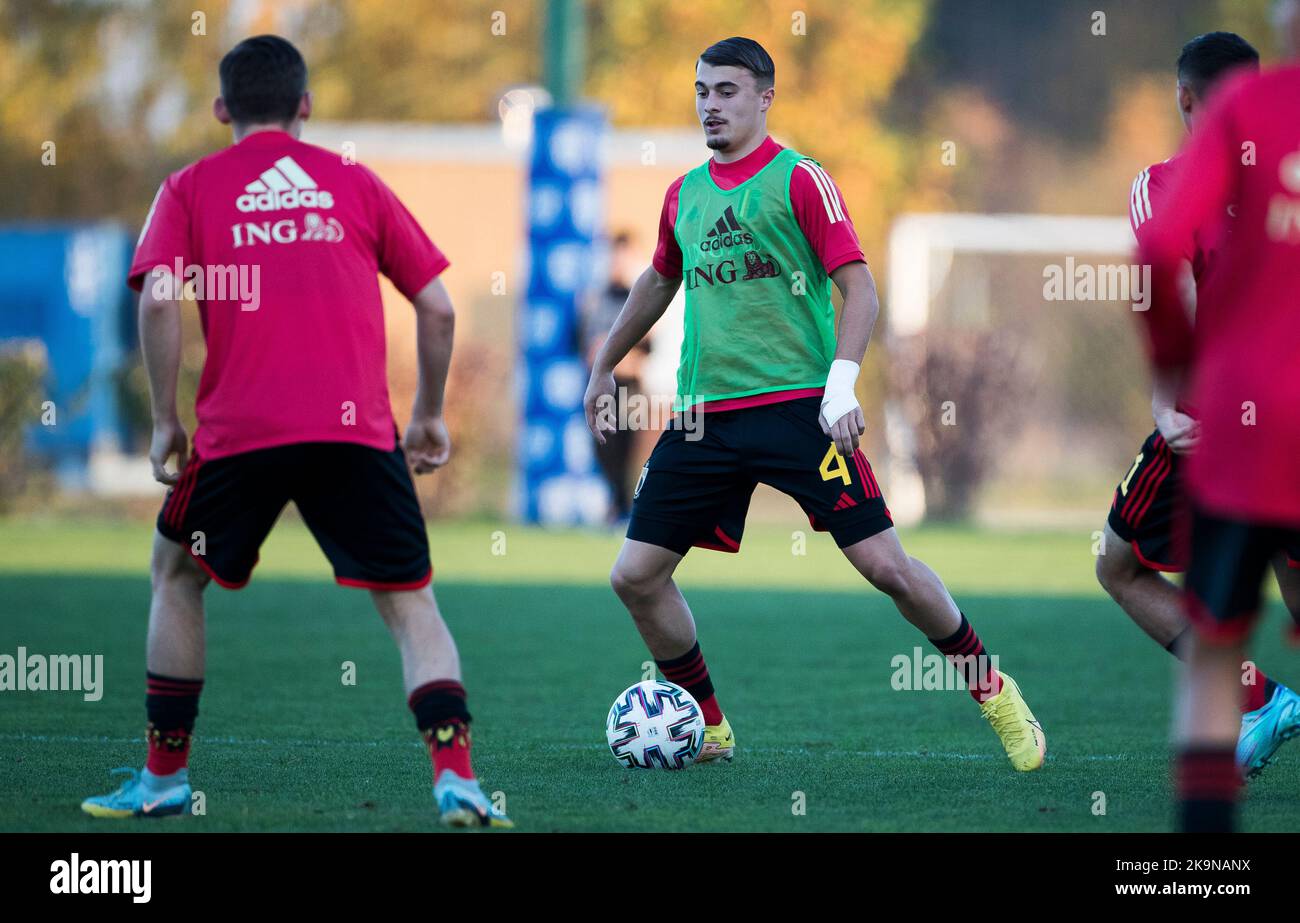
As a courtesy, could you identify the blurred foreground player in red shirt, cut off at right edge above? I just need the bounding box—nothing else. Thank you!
[1140,0,1300,831]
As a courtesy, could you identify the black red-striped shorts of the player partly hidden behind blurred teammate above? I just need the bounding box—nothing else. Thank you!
[1106,429,1300,572]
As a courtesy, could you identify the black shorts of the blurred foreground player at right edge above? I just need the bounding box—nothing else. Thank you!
[1186,507,1300,644]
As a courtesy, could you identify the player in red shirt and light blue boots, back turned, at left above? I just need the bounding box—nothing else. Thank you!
[82,35,510,827]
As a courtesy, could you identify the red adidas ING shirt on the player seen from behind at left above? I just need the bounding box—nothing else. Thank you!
[127,131,449,459]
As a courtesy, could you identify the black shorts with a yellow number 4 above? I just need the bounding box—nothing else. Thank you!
[628,397,893,555]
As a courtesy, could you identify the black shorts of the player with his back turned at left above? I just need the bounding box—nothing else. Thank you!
[157,442,433,590]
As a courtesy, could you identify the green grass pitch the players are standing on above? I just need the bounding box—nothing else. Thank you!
[0,512,1300,832]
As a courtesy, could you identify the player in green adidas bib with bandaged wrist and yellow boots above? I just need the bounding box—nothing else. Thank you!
[585,38,1047,772]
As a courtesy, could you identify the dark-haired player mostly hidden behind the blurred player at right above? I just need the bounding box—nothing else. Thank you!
[1097,33,1300,776]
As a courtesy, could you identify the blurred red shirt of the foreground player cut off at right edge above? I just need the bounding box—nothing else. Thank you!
[1139,68,1300,527]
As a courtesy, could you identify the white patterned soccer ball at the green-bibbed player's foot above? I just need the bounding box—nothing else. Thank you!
[605,680,705,770]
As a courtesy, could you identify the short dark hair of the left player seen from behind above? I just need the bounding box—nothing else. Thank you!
[220,35,307,125]
